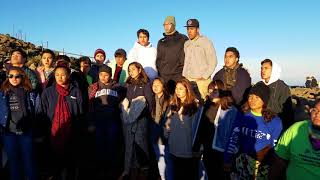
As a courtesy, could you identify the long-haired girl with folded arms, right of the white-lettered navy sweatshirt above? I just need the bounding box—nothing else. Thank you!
[121,62,159,179]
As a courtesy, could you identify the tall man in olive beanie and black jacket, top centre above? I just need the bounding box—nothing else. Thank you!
[156,16,188,94]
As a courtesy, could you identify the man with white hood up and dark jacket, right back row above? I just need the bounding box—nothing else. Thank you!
[261,59,294,130]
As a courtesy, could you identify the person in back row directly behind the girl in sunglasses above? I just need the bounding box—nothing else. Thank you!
[10,48,39,90]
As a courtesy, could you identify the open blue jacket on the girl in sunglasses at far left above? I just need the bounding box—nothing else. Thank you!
[0,91,39,133]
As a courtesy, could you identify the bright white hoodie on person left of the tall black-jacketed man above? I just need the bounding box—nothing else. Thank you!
[127,42,158,80]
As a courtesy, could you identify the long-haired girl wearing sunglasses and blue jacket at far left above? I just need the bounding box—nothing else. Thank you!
[0,67,37,180]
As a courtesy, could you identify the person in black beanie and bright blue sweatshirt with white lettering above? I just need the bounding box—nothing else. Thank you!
[224,82,282,179]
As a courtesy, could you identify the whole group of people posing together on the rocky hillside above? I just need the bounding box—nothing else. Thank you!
[0,16,320,180]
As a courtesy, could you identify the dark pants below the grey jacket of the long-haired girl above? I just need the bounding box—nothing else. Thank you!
[170,154,199,180]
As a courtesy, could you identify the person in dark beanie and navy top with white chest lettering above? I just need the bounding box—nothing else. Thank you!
[87,64,123,179]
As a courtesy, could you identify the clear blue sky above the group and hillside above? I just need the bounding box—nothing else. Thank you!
[0,0,320,85]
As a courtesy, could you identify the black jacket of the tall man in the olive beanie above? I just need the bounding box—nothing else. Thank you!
[156,31,188,82]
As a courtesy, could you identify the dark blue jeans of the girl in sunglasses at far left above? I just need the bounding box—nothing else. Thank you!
[3,133,36,180]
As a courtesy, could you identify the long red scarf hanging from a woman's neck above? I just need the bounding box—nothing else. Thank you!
[51,84,71,154]
